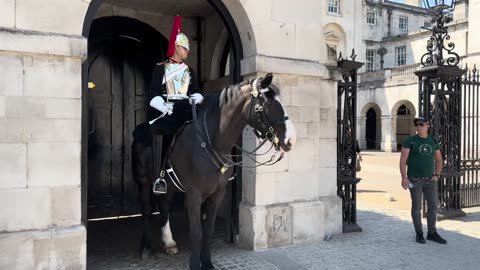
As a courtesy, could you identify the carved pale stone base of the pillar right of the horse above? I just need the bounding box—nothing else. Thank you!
[239,196,342,250]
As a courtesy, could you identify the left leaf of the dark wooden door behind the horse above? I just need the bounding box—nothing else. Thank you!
[88,40,124,218]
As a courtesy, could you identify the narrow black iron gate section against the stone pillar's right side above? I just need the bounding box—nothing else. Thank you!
[337,53,363,233]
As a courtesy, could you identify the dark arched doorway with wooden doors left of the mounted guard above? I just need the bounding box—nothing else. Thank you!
[87,17,168,219]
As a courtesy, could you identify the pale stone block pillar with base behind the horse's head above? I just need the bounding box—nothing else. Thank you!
[239,62,342,250]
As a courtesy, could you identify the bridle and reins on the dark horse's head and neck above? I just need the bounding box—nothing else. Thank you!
[192,79,289,174]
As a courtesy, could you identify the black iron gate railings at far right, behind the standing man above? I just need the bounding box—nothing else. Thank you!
[460,66,480,208]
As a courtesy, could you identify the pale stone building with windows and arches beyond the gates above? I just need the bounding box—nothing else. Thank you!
[357,0,480,151]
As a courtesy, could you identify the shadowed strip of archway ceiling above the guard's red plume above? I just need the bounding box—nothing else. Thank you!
[105,0,215,17]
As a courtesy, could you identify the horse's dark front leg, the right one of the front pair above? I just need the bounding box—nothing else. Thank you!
[200,186,225,270]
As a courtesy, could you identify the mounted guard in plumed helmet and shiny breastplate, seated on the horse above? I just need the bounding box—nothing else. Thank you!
[150,16,203,194]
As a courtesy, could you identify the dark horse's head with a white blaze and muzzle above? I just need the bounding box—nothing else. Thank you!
[244,73,296,152]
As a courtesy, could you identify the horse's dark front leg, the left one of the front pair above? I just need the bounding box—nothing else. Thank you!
[186,192,202,270]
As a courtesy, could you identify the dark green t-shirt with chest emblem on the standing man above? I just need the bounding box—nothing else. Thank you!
[403,135,440,178]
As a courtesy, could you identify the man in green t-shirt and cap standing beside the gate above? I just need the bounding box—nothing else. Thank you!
[400,117,447,244]
